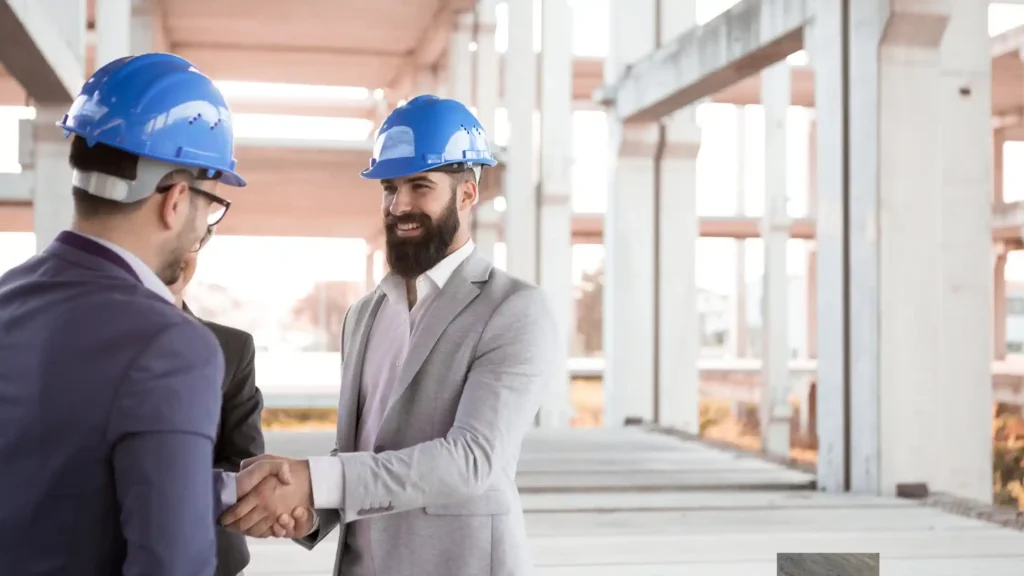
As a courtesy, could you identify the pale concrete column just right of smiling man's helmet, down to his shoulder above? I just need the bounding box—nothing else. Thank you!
[504,0,539,283]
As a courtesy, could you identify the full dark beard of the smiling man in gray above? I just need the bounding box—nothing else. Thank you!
[384,186,459,280]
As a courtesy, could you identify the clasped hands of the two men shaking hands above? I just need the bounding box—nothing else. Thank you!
[220,454,316,538]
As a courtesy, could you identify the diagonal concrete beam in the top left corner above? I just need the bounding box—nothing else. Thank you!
[0,0,85,105]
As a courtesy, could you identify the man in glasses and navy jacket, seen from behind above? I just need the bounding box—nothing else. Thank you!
[0,53,290,576]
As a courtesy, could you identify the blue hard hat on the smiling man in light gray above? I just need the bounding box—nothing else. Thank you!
[361,94,498,179]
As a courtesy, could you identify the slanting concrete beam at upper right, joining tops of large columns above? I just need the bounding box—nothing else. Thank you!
[594,0,811,122]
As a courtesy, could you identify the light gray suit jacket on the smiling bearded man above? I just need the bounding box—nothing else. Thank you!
[298,248,558,576]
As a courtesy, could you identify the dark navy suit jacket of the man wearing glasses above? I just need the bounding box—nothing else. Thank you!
[0,233,233,576]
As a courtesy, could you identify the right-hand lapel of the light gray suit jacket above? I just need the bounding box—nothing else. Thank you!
[384,251,490,415]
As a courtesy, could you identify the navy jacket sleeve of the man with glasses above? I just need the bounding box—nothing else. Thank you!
[109,319,224,576]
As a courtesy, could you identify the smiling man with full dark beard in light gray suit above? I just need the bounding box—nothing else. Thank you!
[221,95,558,576]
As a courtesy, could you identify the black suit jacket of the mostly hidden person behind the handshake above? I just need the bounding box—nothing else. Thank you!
[183,305,265,576]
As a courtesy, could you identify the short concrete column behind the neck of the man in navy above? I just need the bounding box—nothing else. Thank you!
[29,107,75,252]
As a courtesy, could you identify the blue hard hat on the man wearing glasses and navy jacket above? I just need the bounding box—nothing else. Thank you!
[57,53,246,187]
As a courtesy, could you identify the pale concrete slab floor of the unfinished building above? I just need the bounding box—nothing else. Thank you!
[246,428,1024,576]
